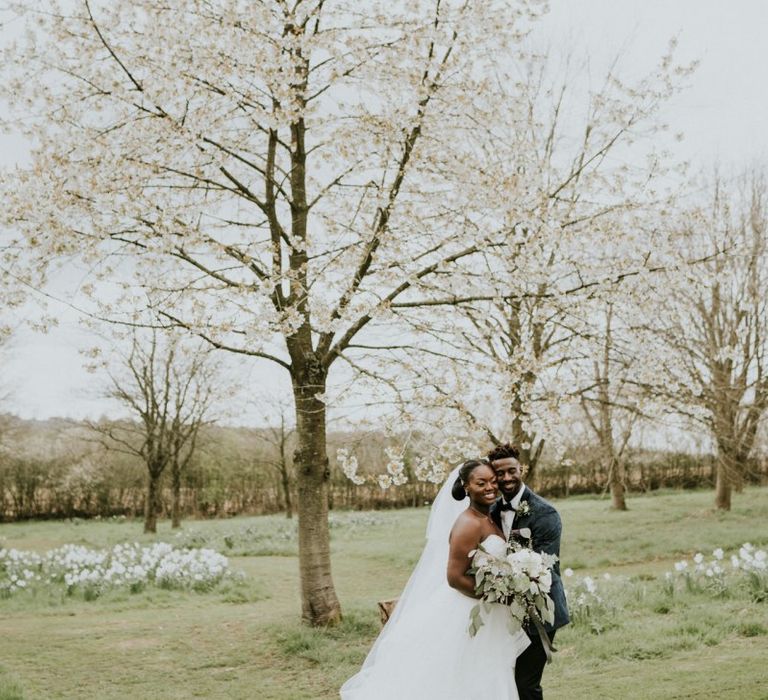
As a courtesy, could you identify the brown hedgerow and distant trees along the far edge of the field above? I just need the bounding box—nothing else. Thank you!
[0,416,768,522]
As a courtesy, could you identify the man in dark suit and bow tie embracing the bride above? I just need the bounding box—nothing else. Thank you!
[488,444,569,700]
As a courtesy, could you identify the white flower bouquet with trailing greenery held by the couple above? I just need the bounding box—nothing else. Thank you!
[469,538,557,637]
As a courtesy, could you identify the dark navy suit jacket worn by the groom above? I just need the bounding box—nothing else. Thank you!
[491,486,570,635]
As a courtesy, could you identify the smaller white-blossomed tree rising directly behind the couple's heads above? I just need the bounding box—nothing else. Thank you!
[342,43,695,482]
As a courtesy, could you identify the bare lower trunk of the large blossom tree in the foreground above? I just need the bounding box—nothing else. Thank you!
[293,367,341,626]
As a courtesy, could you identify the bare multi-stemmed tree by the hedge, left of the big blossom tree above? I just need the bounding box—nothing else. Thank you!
[91,331,222,532]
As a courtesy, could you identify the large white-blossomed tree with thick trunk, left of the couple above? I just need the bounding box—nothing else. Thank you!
[3,0,552,624]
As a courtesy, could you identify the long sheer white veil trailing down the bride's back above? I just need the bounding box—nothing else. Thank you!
[341,467,467,698]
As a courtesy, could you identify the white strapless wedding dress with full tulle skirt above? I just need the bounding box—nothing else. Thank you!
[341,535,529,700]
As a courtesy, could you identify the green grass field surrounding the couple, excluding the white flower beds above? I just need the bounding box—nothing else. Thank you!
[0,488,768,700]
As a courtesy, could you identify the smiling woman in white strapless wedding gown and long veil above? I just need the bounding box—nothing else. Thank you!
[341,460,529,700]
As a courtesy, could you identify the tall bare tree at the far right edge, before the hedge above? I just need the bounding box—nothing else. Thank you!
[652,172,768,510]
